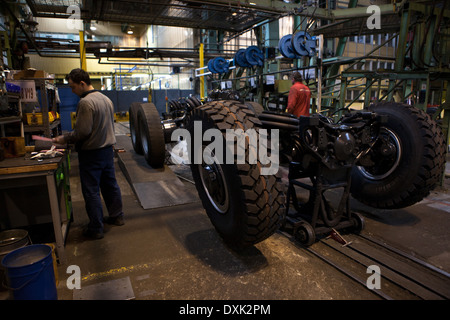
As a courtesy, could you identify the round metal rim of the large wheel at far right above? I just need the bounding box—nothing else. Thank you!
[357,127,402,180]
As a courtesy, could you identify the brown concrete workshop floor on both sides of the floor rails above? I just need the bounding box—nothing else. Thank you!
[53,134,450,300]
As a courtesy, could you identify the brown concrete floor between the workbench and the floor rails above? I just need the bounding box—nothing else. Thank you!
[58,156,380,300]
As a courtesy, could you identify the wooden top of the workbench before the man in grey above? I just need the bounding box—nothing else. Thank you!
[0,153,66,175]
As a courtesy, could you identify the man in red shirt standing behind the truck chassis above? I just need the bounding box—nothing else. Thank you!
[286,72,311,117]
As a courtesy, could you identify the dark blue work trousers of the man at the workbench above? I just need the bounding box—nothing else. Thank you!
[78,146,123,232]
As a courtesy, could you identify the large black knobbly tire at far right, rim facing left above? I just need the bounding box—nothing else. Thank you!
[351,102,445,209]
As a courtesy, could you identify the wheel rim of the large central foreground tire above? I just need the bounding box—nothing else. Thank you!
[198,150,229,214]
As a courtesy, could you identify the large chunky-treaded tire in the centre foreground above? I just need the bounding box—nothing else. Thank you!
[187,101,285,248]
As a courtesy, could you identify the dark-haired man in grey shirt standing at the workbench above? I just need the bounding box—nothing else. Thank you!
[53,69,124,239]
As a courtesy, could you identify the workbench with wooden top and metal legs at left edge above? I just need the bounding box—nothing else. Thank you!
[0,152,72,263]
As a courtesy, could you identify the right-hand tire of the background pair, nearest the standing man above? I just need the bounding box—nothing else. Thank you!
[137,103,166,168]
